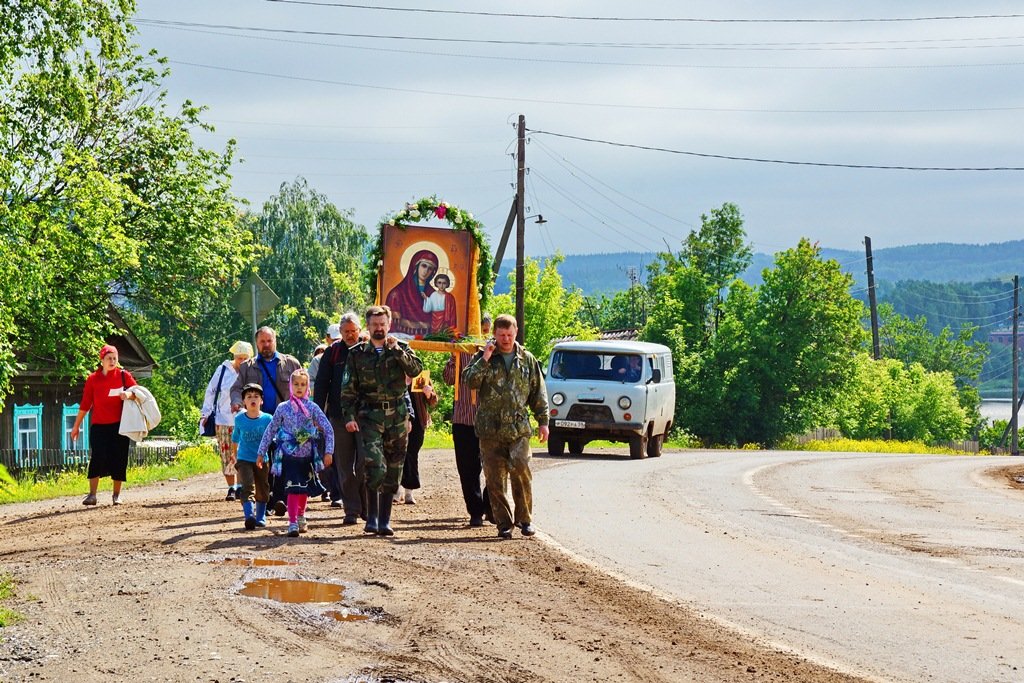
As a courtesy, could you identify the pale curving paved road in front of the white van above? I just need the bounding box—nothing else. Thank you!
[534,451,1024,682]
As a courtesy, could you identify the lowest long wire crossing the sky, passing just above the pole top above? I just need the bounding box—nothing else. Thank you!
[168,59,1024,115]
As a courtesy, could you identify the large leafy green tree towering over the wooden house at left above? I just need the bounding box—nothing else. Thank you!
[0,0,254,404]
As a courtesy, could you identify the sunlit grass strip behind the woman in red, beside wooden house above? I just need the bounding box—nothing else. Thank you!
[0,444,220,505]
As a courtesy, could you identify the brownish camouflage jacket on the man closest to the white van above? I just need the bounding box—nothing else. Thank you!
[462,342,548,441]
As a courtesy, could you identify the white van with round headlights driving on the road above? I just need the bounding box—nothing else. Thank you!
[547,341,676,458]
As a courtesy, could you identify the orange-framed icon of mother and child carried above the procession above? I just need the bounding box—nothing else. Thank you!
[377,225,476,340]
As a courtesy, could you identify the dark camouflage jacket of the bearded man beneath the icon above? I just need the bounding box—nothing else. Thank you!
[341,341,423,424]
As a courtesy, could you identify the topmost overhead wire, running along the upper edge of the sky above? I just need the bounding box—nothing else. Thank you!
[260,0,1024,24]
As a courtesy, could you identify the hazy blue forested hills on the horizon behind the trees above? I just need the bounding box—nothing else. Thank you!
[495,240,1024,389]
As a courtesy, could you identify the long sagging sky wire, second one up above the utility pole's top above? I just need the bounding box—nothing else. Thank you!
[144,25,1024,71]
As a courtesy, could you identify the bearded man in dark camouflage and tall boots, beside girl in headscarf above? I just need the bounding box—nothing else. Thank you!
[341,306,423,536]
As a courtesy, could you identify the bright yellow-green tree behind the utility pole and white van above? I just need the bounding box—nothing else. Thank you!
[490,254,596,366]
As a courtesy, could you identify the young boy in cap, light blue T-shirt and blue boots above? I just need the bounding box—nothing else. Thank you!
[231,382,271,529]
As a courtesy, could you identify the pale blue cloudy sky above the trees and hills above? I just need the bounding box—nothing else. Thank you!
[135,0,1024,257]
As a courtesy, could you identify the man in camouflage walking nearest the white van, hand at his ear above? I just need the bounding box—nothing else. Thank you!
[462,315,548,539]
